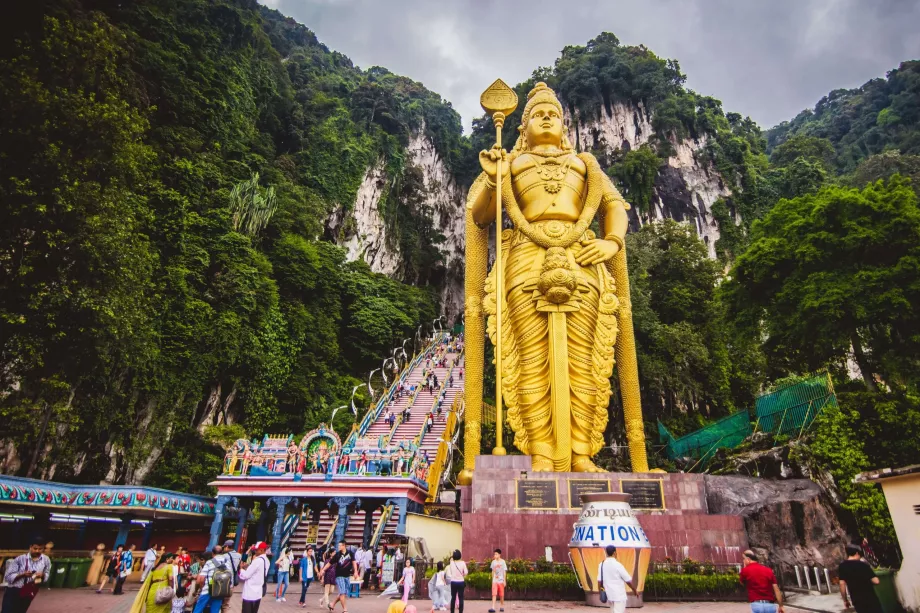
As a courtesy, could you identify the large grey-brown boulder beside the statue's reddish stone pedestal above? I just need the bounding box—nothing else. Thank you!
[706,475,849,570]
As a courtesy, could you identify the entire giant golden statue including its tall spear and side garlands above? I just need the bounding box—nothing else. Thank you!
[460,80,648,476]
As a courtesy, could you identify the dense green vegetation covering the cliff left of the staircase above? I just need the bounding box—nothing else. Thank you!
[0,0,468,491]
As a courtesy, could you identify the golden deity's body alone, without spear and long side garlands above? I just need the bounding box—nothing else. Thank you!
[467,83,641,472]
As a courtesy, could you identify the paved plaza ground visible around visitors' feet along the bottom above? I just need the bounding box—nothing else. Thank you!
[12,588,820,613]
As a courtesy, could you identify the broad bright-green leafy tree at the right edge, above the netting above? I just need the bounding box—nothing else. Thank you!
[727,175,920,389]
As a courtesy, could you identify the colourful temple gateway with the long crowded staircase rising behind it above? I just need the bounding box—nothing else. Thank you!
[210,334,463,572]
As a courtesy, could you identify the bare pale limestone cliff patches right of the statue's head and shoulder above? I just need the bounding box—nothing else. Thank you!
[566,103,731,258]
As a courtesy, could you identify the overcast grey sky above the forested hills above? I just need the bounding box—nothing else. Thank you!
[260,0,920,129]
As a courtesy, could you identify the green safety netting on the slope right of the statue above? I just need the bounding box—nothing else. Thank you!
[658,373,837,465]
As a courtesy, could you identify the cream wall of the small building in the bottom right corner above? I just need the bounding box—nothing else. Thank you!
[882,474,920,613]
